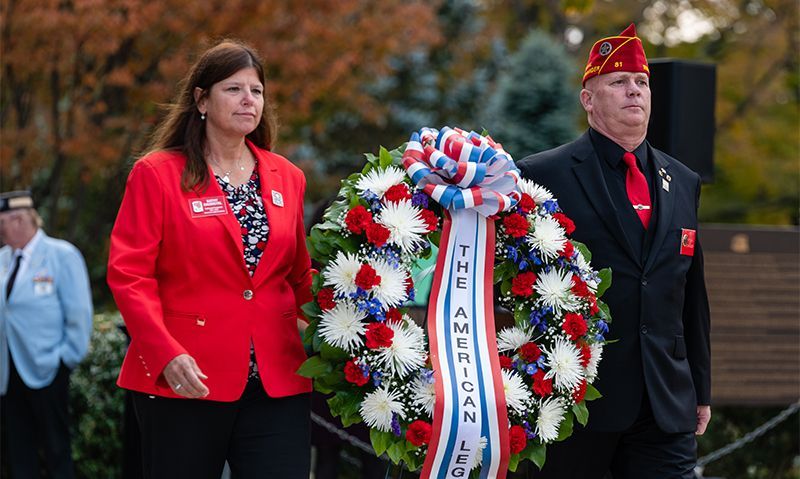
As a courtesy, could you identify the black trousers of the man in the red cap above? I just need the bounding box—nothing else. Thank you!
[533,395,697,479]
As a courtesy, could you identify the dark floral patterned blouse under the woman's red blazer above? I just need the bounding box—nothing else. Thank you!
[214,161,269,378]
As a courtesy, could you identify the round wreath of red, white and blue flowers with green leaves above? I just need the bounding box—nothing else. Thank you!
[299,130,611,472]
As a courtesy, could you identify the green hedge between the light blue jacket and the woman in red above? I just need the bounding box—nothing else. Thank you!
[70,313,127,479]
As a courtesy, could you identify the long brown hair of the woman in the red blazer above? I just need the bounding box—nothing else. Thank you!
[147,39,277,191]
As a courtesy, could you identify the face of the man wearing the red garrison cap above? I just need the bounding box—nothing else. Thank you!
[581,72,650,133]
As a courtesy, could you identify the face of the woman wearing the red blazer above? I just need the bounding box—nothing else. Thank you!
[195,67,264,142]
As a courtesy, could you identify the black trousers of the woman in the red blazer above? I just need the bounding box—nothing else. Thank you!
[133,379,311,479]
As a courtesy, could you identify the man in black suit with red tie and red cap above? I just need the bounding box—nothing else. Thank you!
[517,25,711,479]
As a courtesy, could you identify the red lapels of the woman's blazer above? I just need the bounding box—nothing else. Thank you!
[188,139,291,285]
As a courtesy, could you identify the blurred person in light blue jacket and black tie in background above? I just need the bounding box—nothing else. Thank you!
[0,191,92,479]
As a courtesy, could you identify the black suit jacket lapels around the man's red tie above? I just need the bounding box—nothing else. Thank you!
[572,131,677,272]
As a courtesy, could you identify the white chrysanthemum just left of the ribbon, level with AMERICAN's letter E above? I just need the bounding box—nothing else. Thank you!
[377,321,426,378]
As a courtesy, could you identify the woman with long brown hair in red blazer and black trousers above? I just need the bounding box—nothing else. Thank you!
[108,40,311,479]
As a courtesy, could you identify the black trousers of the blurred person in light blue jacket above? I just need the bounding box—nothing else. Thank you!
[0,355,75,479]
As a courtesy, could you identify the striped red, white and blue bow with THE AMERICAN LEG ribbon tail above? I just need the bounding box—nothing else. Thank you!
[403,127,519,478]
